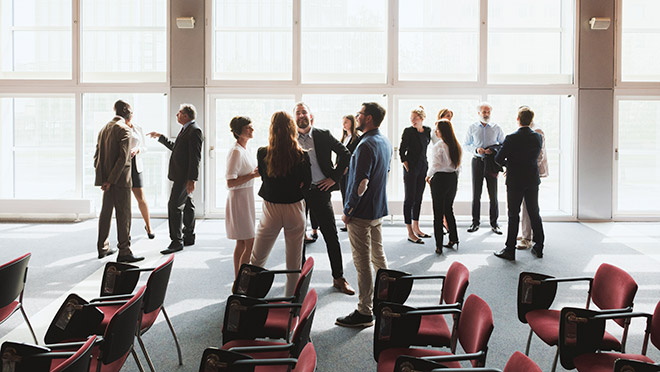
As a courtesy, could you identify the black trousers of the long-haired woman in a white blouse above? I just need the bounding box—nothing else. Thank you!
[431,172,458,248]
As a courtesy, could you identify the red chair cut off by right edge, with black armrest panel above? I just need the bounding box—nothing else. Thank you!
[559,302,660,372]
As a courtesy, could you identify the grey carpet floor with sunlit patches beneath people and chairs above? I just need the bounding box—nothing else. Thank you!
[0,219,660,372]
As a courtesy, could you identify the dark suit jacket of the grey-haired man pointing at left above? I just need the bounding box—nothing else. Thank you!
[158,122,204,182]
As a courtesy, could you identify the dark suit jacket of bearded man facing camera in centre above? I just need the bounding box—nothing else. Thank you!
[312,127,351,191]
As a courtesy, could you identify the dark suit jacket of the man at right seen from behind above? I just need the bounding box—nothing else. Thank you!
[495,127,543,188]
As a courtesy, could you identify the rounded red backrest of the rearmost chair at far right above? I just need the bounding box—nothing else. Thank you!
[591,263,637,327]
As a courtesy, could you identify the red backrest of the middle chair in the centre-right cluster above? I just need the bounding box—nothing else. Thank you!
[458,294,493,367]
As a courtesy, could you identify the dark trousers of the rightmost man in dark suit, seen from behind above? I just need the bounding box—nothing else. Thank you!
[506,185,545,251]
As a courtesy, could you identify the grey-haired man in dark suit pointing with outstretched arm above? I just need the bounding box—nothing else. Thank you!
[148,104,204,254]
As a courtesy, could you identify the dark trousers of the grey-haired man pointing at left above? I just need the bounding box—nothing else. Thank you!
[167,182,195,245]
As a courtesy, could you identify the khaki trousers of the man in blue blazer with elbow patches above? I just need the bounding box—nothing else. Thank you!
[346,217,387,315]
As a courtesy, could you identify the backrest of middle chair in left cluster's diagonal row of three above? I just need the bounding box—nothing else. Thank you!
[101,286,146,364]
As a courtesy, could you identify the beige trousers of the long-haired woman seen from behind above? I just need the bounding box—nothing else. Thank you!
[250,200,305,296]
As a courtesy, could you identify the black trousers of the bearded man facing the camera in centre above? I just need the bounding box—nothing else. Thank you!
[303,186,344,279]
